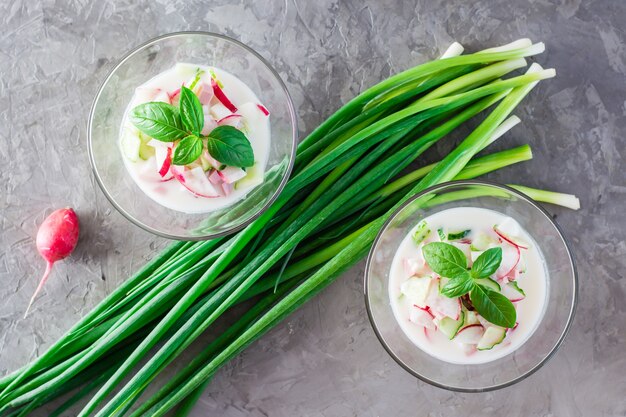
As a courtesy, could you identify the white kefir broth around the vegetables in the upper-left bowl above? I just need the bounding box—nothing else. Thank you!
[120,63,270,213]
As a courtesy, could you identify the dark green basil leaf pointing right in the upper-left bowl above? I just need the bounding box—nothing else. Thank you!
[207,126,254,168]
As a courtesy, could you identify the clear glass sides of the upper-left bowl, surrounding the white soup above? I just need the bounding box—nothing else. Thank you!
[88,32,297,240]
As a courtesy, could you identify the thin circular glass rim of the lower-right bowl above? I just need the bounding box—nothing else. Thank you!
[363,180,578,393]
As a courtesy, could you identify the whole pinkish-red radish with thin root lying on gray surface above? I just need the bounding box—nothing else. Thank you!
[24,207,79,317]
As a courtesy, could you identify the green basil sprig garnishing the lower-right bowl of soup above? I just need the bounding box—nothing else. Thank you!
[422,242,517,328]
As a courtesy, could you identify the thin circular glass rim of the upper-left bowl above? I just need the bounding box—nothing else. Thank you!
[87,31,298,241]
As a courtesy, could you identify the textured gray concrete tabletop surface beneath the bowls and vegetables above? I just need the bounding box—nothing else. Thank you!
[0,0,626,417]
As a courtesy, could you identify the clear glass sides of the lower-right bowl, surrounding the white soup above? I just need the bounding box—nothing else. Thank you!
[365,181,577,392]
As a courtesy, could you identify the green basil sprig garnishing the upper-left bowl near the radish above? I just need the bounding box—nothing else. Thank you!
[130,79,254,168]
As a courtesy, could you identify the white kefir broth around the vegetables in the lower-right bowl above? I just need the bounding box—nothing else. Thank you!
[389,207,548,364]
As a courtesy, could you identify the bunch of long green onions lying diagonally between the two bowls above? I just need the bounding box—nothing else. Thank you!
[0,39,577,416]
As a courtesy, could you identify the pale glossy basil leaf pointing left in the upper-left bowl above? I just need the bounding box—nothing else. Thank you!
[130,102,188,142]
